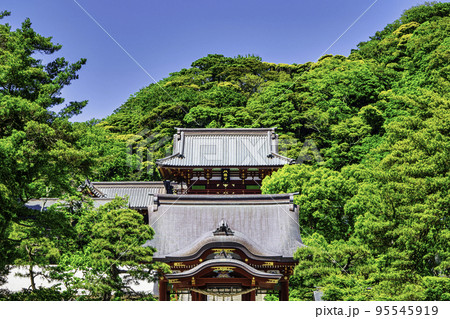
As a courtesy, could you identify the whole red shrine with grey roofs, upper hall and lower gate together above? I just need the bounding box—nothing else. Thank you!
[146,128,303,301]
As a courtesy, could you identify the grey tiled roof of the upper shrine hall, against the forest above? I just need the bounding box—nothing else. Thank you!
[157,128,293,167]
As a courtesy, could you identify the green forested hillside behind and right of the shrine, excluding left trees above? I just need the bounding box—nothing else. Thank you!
[88,3,450,300]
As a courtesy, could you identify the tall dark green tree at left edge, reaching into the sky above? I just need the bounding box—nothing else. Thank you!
[0,12,90,289]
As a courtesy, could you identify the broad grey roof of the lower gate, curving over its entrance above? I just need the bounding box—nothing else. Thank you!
[146,194,303,260]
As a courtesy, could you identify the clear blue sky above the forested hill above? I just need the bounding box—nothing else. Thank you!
[0,0,442,121]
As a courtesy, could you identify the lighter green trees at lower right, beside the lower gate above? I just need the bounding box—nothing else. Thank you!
[284,84,450,300]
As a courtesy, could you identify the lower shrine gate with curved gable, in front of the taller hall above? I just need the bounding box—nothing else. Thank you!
[148,194,302,301]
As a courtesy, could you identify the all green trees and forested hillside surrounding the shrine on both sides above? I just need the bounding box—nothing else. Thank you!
[0,3,450,300]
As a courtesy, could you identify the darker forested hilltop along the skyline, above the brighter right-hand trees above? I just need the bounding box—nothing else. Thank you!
[85,3,449,180]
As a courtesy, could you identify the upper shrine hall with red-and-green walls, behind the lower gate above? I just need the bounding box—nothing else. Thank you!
[157,128,293,195]
